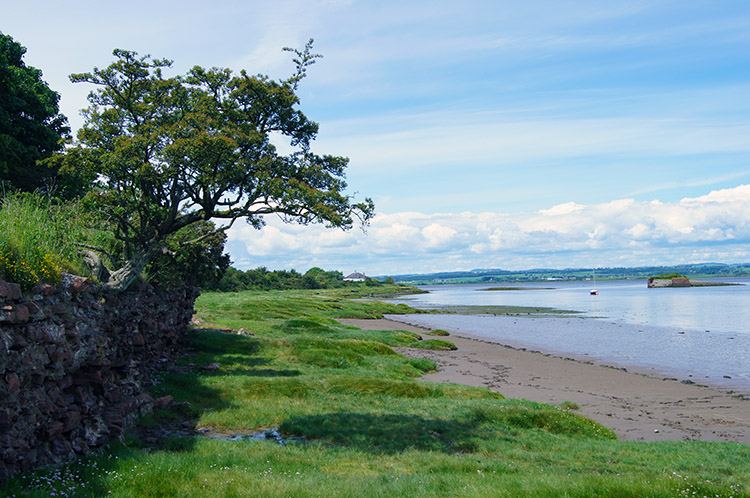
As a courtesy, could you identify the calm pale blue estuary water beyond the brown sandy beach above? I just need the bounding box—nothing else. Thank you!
[390,279,750,392]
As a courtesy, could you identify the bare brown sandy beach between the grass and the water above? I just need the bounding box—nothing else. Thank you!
[339,319,750,444]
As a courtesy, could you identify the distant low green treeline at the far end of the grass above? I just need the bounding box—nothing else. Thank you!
[206,266,383,292]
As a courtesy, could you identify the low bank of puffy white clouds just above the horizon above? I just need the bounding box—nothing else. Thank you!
[227,185,750,275]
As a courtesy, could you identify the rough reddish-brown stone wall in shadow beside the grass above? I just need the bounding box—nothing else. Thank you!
[0,275,198,480]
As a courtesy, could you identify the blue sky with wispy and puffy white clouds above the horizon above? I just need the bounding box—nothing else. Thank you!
[5,0,750,275]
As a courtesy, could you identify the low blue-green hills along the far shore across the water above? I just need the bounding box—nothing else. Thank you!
[377,263,750,285]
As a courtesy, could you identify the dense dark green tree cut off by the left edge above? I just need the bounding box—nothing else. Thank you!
[0,33,70,192]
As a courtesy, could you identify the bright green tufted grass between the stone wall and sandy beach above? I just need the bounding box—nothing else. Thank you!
[0,289,750,498]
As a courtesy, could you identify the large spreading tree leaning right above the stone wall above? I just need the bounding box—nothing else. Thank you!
[63,40,374,289]
